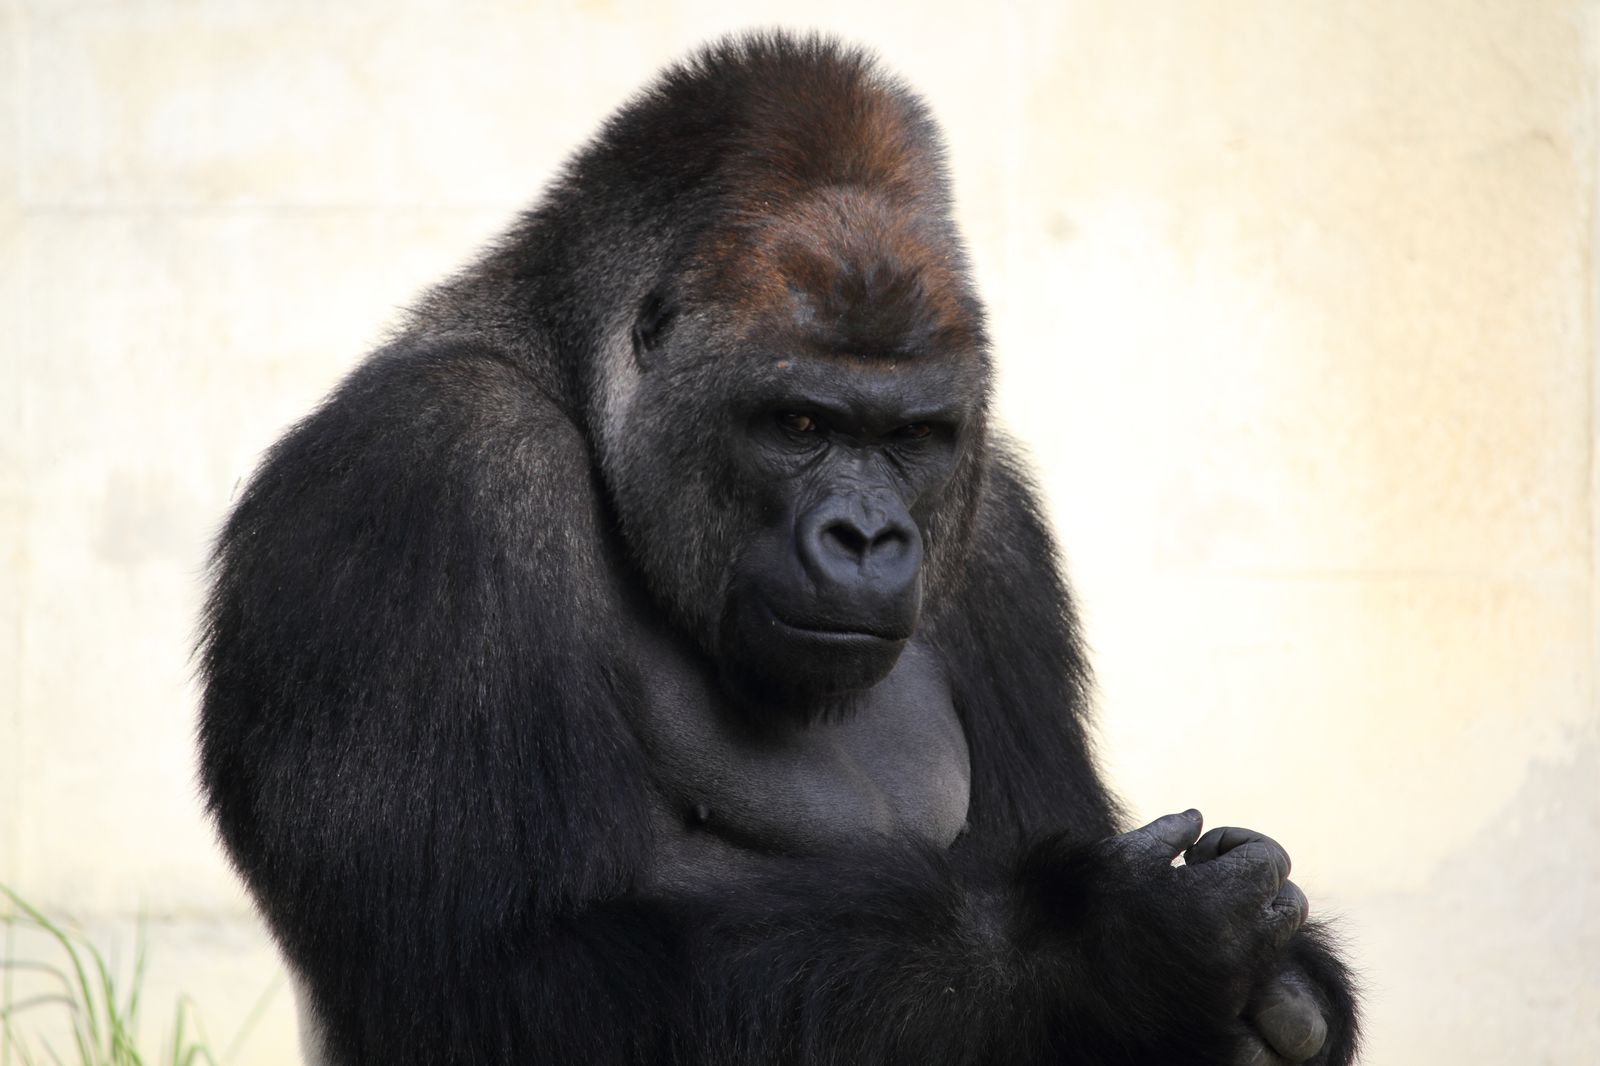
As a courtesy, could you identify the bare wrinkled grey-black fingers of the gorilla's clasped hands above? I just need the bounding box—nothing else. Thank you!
[1107,810,1328,1066]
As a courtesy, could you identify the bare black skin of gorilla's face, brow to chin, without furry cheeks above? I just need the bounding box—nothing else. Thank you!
[717,355,966,698]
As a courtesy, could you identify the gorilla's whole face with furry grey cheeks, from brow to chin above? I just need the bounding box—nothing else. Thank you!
[606,302,986,711]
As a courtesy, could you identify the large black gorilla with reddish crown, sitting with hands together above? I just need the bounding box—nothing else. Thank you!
[198,34,1357,1066]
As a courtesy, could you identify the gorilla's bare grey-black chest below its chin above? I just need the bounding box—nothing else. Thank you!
[634,630,971,877]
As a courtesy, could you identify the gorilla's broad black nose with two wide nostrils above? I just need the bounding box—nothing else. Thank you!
[798,496,922,601]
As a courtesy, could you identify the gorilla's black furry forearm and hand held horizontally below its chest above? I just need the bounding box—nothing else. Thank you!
[662,815,1299,1064]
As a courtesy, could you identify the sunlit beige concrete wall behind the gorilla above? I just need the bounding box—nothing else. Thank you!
[0,0,1600,1066]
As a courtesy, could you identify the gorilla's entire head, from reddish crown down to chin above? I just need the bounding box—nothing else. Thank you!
[590,42,989,711]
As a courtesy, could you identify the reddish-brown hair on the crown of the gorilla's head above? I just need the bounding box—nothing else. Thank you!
[669,37,982,359]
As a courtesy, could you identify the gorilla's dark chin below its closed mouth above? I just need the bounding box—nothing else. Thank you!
[717,595,910,719]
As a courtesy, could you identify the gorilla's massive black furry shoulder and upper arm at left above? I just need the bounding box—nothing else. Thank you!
[200,346,669,1063]
